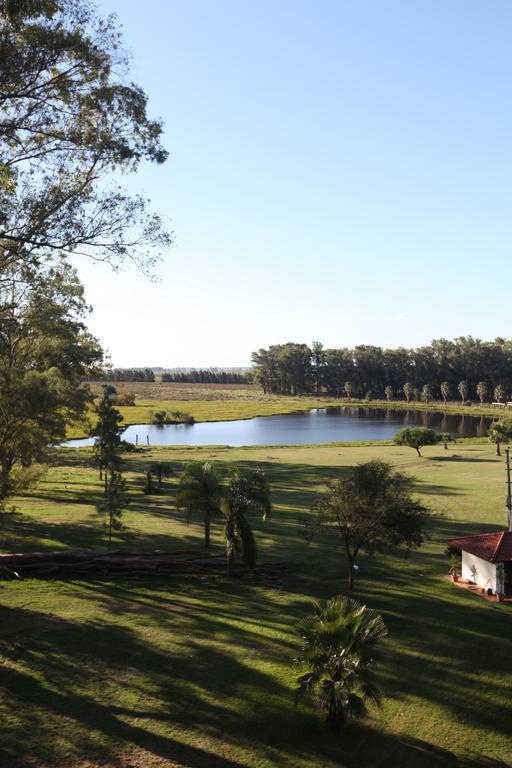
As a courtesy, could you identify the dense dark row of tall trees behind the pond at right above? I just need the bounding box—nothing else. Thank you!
[252,336,512,401]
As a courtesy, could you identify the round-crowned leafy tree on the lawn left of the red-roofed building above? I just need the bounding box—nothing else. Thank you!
[306,460,427,590]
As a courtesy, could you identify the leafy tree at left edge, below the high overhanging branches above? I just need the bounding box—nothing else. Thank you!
[0,258,102,499]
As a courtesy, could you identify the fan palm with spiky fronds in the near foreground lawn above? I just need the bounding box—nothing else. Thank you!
[296,597,387,729]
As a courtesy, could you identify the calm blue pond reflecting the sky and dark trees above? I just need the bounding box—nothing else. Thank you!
[64,406,492,447]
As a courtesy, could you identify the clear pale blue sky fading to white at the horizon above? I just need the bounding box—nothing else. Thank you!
[81,0,512,367]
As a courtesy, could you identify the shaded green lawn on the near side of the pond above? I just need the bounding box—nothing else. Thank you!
[0,441,512,768]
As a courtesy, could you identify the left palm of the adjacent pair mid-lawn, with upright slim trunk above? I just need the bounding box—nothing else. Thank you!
[176,461,223,549]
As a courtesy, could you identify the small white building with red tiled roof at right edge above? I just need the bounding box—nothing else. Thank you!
[448,531,512,595]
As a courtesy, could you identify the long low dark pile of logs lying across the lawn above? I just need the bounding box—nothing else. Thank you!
[0,550,288,579]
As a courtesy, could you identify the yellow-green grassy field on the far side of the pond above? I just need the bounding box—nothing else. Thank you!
[68,381,510,438]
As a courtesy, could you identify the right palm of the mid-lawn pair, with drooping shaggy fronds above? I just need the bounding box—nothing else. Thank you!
[223,470,272,576]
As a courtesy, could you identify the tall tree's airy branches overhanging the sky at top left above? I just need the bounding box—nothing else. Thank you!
[0,0,171,270]
